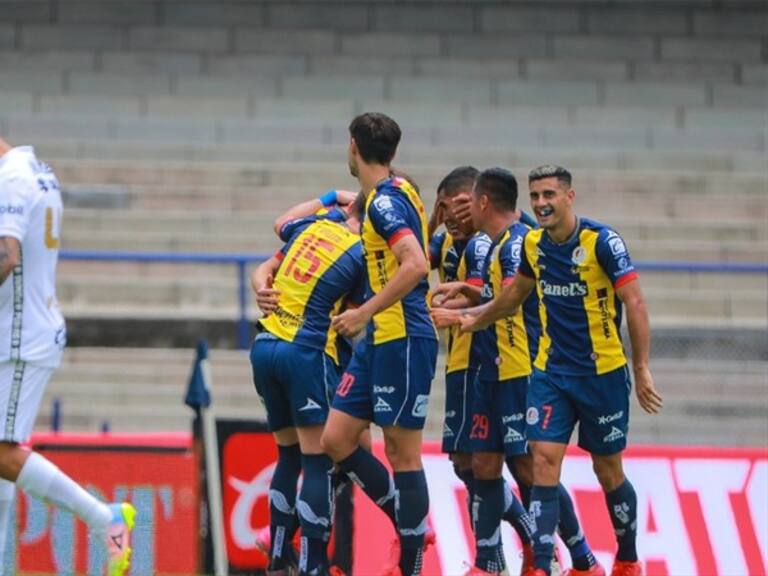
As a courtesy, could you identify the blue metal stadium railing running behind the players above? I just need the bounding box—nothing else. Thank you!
[60,250,768,350]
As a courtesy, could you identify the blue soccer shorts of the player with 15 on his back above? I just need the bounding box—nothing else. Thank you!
[251,332,339,431]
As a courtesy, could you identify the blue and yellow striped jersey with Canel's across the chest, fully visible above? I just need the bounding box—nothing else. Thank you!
[520,218,637,375]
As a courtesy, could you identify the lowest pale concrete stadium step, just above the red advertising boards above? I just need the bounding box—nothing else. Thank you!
[37,348,768,445]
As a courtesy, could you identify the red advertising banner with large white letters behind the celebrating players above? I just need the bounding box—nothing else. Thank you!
[216,432,768,576]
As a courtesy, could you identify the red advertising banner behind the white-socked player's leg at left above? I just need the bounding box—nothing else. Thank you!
[7,434,199,575]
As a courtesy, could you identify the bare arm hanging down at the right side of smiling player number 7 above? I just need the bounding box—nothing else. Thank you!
[616,279,663,414]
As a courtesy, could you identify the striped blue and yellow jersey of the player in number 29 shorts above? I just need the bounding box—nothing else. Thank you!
[476,222,540,381]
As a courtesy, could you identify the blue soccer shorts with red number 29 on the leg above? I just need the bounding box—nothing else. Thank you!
[470,376,529,457]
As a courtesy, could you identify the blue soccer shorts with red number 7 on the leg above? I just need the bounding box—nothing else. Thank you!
[526,366,632,455]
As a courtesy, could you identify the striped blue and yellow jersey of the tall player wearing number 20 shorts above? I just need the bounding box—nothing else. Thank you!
[362,177,437,344]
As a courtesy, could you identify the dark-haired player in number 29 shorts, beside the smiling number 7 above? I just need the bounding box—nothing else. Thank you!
[435,168,602,576]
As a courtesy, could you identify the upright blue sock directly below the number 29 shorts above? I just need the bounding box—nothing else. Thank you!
[472,478,504,574]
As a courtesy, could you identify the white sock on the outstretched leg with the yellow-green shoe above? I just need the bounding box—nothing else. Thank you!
[16,452,112,531]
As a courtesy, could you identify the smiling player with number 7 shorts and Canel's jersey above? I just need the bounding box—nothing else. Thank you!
[462,165,662,576]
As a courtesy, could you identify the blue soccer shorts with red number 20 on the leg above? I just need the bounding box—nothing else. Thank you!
[333,337,437,430]
